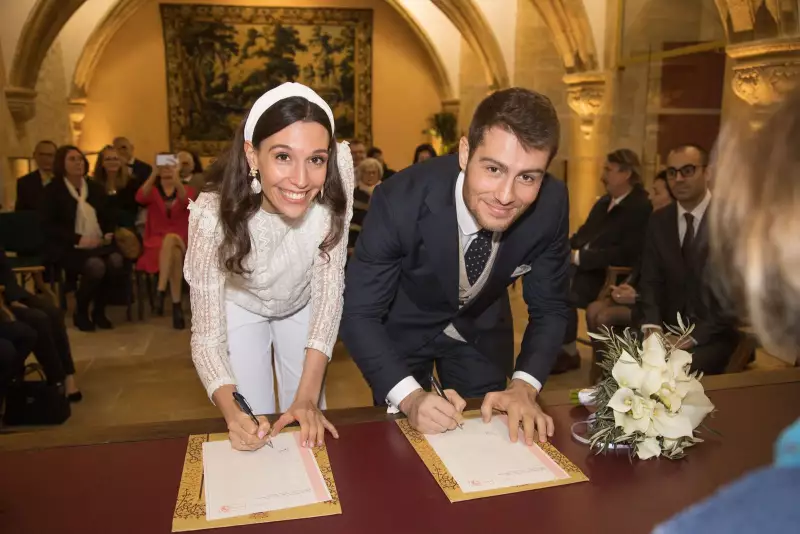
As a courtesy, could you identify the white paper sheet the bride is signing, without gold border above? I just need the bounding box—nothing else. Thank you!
[203,432,331,521]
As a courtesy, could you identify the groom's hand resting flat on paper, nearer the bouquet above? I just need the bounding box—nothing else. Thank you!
[481,380,553,445]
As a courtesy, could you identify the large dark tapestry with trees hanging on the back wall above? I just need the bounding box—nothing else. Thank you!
[161,4,372,156]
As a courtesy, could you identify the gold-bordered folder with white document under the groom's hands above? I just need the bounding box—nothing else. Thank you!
[398,414,588,502]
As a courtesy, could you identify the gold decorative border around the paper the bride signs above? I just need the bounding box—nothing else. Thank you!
[172,434,342,532]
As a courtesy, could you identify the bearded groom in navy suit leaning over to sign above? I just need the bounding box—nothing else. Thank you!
[340,88,569,443]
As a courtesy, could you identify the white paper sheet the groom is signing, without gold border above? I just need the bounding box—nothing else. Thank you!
[425,416,569,493]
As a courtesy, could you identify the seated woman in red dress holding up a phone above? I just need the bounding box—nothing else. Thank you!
[136,156,197,330]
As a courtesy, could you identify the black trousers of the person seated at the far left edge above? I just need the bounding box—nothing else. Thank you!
[11,294,75,384]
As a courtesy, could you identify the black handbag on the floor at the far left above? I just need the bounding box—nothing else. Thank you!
[3,364,72,426]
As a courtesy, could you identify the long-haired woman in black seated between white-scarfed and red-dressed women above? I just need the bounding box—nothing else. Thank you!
[92,145,141,228]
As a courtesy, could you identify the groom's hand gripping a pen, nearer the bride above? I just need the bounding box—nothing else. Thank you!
[399,389,467,434]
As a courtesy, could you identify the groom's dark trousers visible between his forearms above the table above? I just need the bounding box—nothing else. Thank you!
[375,332,514,405]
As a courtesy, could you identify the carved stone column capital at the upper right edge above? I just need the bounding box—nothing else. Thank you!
[726,36,800,129]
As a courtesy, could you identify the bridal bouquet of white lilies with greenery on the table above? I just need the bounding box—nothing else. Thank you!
[589,315,714,460]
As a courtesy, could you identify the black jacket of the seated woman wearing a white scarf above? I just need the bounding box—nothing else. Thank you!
[41,178,116,262]
